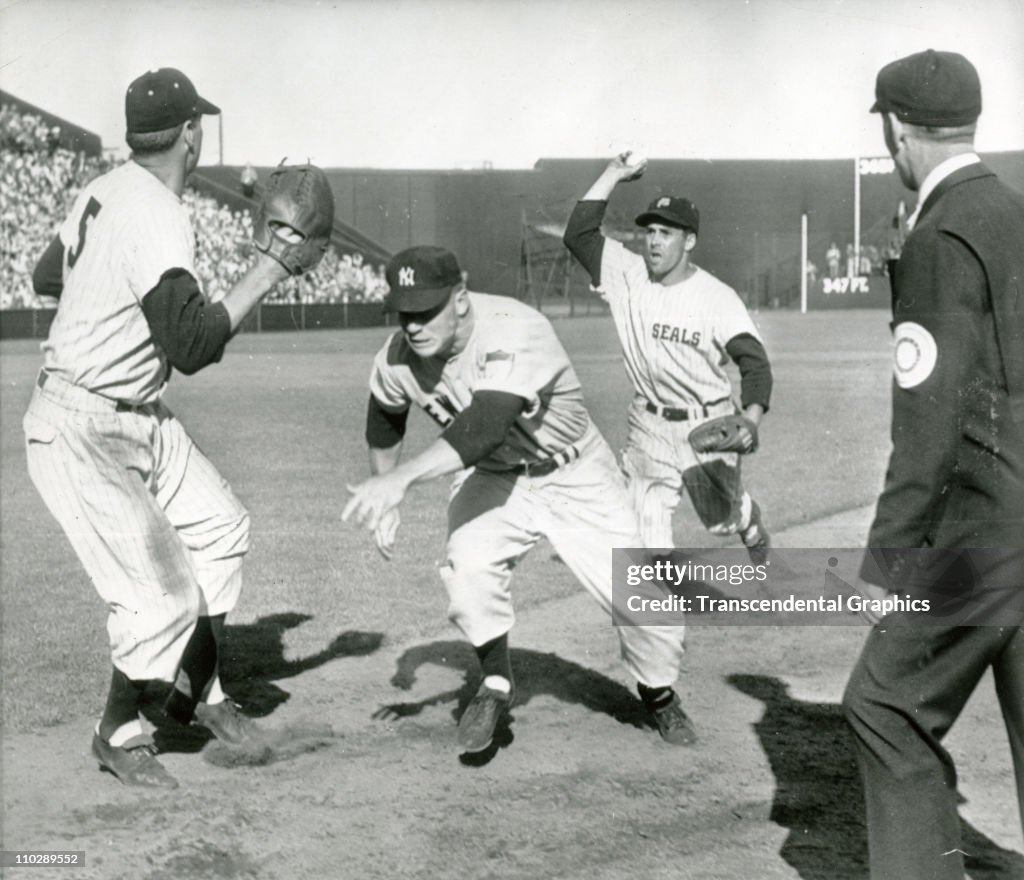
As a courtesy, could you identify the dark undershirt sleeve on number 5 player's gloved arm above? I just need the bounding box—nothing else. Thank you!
[142,268,231,375]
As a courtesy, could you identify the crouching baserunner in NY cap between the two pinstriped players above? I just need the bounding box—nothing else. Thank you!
[342,247,695,752]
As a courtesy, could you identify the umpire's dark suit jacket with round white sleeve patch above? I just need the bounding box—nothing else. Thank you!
[861,164,1024,588]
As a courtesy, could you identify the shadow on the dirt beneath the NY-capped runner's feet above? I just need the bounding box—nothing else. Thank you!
[374,640,653,766]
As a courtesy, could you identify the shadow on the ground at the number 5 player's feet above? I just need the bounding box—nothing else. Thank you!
[142,612,384,751]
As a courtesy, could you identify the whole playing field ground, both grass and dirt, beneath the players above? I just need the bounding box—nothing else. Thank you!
[0,316,1024,880]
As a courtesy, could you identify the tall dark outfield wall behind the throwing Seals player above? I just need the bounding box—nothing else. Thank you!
[195,149,1024,307]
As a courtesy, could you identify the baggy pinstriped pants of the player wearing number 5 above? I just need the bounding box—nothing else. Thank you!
[23,375,249,681]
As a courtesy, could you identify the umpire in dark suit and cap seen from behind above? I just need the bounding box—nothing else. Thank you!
[843,50,1024,880]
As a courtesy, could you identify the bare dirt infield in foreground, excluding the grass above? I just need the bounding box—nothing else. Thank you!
[3,510,1024,880]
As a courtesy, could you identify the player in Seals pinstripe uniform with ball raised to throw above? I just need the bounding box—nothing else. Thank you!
[564,153,772,562]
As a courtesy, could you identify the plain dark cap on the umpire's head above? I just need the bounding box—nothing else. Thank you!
[871,49,981,126]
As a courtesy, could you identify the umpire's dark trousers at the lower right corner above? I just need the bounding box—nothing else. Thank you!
[843,573,1024,880]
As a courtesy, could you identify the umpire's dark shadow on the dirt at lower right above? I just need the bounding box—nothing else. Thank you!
[727,674,1024,880]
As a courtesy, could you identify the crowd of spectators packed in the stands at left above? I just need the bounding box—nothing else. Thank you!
[0,106,387,308]
